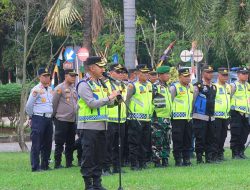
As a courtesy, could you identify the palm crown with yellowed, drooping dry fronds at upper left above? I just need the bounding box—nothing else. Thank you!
[44,0,104,51]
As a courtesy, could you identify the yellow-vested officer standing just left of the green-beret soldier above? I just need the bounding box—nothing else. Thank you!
[126,65,153,170]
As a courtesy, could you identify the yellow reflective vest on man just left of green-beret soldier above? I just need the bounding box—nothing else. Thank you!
[128,81,153,121]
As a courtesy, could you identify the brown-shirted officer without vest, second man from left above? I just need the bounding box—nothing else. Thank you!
[52,69,78,168]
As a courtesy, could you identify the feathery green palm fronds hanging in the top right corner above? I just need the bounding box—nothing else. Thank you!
[176,0,250,64]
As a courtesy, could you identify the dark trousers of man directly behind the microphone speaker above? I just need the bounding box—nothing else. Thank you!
[103,122,125,170]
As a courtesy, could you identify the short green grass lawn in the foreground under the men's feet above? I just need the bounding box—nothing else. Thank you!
[0,150,250,190]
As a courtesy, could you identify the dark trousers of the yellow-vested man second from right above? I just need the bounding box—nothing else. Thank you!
[214,118,229,156]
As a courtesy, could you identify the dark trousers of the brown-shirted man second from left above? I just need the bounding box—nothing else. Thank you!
[54,119,76,166]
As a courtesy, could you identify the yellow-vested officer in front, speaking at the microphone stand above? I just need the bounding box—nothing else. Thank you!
[77,56,118,190]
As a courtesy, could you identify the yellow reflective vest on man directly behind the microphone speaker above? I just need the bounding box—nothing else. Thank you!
[106,80,127,123]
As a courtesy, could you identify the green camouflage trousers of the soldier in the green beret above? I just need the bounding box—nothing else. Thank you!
[151,118,171,162]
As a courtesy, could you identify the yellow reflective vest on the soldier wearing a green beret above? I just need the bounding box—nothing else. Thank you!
[153,83,172,118]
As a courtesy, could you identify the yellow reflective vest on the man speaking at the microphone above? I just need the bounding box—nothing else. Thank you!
[78,81,108,122]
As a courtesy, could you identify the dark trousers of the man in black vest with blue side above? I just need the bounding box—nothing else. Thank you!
[193,119,217,160]
